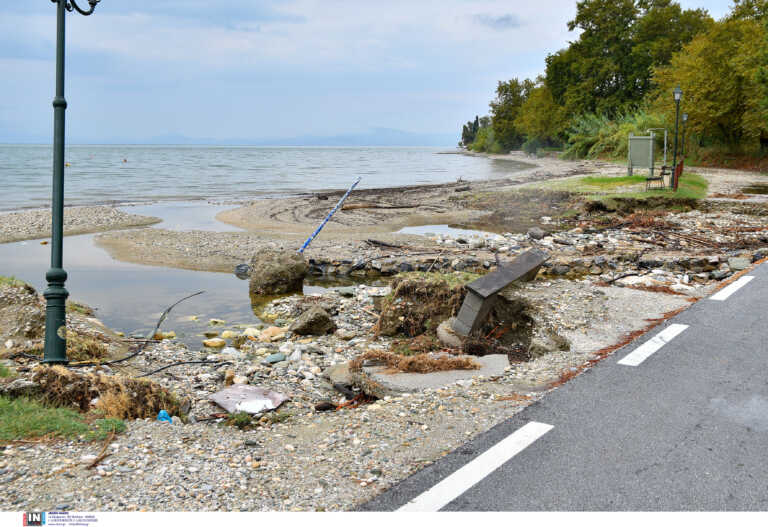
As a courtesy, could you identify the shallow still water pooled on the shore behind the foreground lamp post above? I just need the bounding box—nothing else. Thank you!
[0,203,348,349]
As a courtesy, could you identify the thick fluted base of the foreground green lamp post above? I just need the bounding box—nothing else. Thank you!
[43,269,69,364]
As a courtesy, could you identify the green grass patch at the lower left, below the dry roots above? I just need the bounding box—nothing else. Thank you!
[0,396,125,441]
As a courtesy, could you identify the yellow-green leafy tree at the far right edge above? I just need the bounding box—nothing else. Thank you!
[654,18,768,152]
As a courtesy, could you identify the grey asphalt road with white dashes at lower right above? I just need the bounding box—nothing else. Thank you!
[360,264,768,511]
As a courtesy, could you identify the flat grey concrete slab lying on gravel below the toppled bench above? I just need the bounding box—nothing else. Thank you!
[354,355,509,398]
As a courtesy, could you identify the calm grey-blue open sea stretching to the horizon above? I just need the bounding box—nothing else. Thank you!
[0,145,525,211]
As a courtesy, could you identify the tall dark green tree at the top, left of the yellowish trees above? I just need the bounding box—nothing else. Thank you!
[546,0,713,117]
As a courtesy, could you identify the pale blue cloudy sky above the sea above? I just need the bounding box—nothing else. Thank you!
[0,0,731,144]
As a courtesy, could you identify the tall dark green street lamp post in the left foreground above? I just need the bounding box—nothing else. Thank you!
[43,0,100,364]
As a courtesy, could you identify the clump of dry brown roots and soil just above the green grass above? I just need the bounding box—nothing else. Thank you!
[31,366,181,419]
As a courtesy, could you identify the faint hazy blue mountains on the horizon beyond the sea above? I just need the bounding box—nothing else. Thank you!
[0,128,458,147]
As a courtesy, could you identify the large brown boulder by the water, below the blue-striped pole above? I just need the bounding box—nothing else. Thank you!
[250,249,307,296]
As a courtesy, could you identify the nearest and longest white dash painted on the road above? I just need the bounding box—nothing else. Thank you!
[398,421,554,512]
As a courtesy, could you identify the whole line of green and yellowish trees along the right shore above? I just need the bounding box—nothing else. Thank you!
[460,0,768,165]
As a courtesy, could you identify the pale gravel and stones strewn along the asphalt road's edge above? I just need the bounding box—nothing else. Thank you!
[0,280,687,511]
